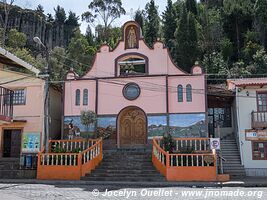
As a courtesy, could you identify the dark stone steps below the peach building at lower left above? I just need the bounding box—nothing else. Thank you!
[0,158,36,179]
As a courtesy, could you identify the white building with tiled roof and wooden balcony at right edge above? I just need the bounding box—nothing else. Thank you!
[227,78,267,176]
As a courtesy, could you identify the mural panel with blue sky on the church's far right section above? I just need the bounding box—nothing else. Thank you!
[170,113,207,137]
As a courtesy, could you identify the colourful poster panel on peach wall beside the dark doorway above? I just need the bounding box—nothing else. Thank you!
[21,132,41,153]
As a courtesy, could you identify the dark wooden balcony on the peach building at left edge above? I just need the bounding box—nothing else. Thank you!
[0,86,13,125]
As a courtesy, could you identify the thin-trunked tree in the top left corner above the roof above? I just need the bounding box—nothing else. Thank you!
[0,0,15,46]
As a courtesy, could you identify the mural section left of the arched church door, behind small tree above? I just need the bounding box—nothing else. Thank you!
[64,116,116,139]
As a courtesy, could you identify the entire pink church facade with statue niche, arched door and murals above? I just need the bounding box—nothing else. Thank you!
[62,21,208,148]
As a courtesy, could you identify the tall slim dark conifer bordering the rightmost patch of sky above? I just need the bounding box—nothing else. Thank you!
[162,0,176,56]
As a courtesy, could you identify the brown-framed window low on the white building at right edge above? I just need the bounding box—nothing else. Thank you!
[252,141,267,160]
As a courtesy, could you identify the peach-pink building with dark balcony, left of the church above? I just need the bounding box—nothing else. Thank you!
[0,48,62,178]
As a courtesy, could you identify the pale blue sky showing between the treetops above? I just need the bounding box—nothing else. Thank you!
[15,0,174,33]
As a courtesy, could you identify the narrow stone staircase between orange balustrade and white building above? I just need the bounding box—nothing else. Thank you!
[221,138,246,177]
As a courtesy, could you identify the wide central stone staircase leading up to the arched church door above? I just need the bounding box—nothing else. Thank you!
[82,149,165,182]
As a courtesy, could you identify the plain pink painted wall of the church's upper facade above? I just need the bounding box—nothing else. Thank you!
[64,22,206,116]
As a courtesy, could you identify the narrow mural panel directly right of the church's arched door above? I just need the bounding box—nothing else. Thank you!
[147,115,167,138]
